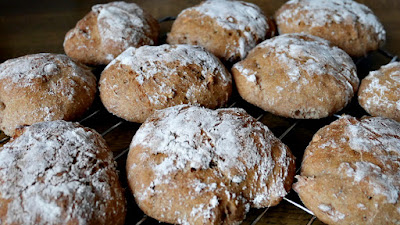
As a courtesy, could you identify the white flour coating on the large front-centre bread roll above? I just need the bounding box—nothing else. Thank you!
[130,105,292,220]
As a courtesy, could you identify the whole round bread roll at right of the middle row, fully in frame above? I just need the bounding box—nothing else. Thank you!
[232,34,359,119]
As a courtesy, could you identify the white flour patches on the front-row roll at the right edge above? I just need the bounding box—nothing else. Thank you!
[339,116,400,203]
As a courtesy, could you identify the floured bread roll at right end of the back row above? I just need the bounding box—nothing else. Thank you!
[275,0,386,57]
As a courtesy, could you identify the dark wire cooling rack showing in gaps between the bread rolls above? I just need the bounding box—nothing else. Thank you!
[0,17,398,225]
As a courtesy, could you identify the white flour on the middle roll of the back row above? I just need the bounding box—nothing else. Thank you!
[188,0,269,59]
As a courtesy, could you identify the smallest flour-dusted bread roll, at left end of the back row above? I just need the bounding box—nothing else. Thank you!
[64,2,160,65]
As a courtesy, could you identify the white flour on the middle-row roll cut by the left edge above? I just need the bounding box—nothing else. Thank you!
[0,53,94,89]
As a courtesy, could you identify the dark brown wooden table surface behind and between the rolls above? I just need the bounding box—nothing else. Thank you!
[0,0,400,225]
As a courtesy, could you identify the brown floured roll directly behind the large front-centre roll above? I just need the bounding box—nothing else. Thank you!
[100,45,232,123]
